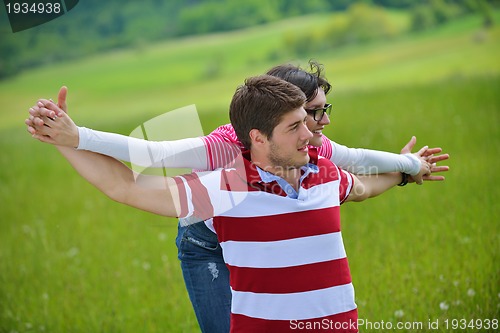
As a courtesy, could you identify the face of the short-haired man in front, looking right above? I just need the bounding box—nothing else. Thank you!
[268,107,313,170]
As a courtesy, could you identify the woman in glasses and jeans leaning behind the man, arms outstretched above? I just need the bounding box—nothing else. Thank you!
[27,61,447,332]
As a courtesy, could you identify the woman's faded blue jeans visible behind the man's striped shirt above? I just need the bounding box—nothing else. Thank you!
[176,222,231,333]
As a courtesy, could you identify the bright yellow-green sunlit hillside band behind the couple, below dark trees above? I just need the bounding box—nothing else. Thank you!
[0,13,500,128]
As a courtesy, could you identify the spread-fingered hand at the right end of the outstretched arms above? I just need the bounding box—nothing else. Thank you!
[401,136,450,185]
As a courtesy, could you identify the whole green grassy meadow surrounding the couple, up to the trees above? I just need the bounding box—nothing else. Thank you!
[0,12,500,333]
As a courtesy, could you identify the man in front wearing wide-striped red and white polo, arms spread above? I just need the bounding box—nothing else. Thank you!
[27,76,436,332]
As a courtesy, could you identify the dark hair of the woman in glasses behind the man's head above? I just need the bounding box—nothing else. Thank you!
[266,60,332,102]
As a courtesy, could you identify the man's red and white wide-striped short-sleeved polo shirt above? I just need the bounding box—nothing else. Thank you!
[176,149,357,333]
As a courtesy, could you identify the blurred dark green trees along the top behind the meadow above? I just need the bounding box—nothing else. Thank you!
[0,0,495,79]
